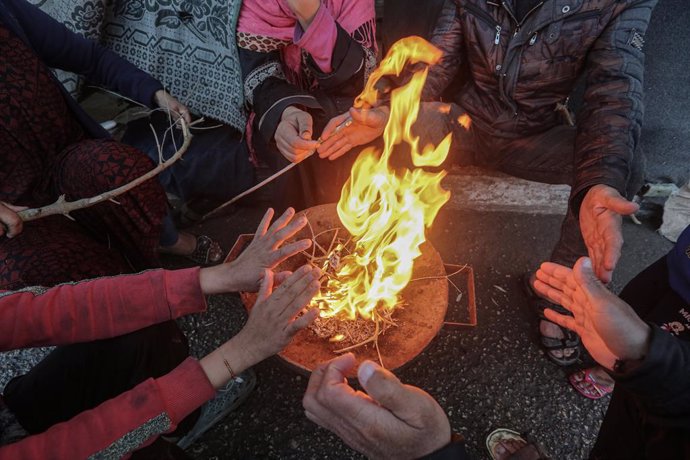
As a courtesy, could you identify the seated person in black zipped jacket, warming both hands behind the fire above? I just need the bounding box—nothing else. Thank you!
[318,0,657,366]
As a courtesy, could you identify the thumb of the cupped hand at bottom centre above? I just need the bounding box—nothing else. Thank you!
[357,361,410,419]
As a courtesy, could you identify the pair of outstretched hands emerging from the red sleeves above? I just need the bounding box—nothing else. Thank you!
[199,208,321,388]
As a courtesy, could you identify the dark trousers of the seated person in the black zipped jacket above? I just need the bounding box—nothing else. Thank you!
[415,102,644,266]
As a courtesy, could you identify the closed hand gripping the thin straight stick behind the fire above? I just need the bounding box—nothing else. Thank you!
[274,106,319,163]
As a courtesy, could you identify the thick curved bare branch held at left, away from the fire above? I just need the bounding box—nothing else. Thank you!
[17,117,192,222]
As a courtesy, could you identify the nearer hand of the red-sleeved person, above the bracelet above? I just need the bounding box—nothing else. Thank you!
[236,265,321,365]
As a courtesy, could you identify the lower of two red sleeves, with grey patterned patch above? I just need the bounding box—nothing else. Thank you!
[0,358,215,460]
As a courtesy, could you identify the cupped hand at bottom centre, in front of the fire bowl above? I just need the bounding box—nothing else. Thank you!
[302,353,451,459]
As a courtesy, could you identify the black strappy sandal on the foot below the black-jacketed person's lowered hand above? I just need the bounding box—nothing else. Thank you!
[522,272,580,367]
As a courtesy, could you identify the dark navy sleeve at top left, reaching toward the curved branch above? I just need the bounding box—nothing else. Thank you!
[0,0,163,138]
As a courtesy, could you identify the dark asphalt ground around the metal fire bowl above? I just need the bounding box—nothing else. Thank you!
[168,208,671,459]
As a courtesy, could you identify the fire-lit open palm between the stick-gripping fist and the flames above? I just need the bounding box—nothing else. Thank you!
[318,106,390,160]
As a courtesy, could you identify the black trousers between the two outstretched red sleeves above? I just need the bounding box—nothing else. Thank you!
[3,321,198,458]
